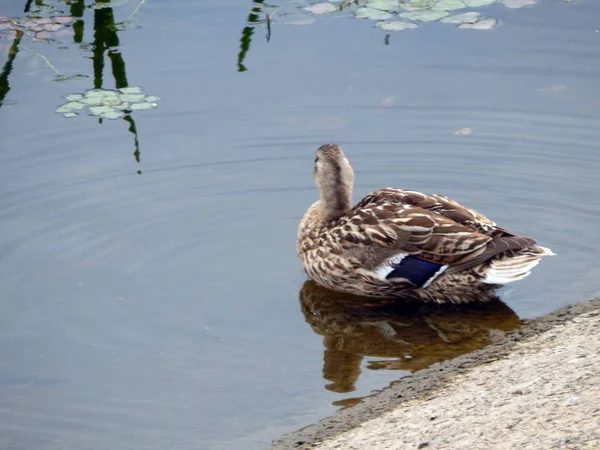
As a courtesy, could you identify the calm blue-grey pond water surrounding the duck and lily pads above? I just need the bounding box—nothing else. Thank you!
[0,0,600,450]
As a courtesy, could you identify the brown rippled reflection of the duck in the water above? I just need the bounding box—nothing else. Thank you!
[300,280,523,406]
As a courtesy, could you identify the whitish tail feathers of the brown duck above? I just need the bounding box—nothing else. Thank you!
[481,245,555,284]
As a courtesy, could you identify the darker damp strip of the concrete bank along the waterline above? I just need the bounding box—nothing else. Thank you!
[271,298,600,450]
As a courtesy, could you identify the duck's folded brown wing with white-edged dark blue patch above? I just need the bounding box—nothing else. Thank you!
[334,189,535,286]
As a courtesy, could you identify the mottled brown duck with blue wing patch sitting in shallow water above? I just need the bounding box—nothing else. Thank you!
[296,144,554,303]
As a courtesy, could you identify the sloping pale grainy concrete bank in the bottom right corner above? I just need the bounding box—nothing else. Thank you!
[273,299,600,450]
